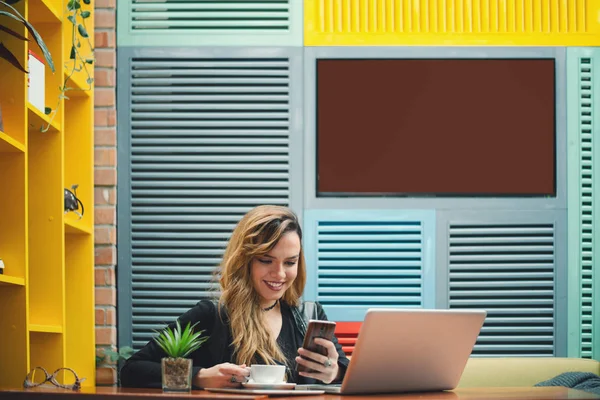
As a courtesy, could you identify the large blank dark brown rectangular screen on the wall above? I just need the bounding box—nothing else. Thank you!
[317,59,556,196]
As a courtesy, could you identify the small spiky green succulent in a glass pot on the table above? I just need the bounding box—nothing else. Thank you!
[155,321,208,392]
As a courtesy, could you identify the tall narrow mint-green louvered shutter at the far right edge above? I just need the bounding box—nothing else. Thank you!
[567,47,600,359]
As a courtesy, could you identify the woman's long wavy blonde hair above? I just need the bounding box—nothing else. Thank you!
[219,205,306,365]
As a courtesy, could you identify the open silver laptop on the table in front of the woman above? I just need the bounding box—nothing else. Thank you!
[296,308,487,394]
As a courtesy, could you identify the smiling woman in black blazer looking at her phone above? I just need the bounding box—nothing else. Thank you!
[121,206,349,388]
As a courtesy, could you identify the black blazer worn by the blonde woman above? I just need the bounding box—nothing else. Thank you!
[120,300,350,389]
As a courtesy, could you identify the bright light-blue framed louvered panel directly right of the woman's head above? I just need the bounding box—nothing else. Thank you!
[304,210,435,321]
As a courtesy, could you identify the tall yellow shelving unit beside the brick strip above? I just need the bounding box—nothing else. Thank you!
[0,0,95,387]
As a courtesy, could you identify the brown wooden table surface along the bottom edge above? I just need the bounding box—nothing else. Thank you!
[0,387,600,400]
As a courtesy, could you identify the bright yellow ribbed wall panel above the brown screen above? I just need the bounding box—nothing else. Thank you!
[304,0,600,46]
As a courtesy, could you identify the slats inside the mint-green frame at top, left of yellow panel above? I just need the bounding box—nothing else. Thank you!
[130,0,290,34]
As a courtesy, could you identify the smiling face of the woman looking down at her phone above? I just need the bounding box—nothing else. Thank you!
[250,231,300,308]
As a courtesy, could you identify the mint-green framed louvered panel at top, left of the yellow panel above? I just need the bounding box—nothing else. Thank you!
[117,0,303,46]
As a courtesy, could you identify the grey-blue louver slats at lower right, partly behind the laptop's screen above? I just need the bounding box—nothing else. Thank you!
[448,223,555,357]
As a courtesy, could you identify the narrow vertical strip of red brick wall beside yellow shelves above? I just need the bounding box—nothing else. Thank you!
[94,0,117,385]
